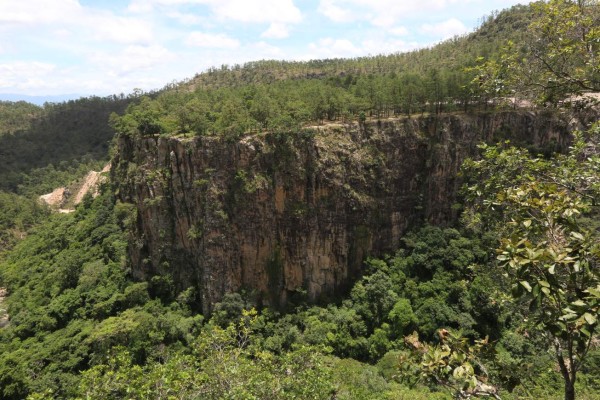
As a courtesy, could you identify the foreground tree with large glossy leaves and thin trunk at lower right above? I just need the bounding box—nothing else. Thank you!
[466,125,600,398]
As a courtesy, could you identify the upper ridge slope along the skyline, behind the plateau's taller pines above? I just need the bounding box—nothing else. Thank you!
[182,5,532,89]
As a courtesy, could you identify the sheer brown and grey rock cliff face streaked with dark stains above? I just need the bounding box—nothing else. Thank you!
[111,112,571,312]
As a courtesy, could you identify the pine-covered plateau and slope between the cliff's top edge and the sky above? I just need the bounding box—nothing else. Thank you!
[113,6,530,139]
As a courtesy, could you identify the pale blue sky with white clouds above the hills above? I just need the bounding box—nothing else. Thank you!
[0,0,525,96]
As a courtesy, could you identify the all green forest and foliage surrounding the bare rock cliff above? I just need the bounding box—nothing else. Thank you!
[0,0,600,399]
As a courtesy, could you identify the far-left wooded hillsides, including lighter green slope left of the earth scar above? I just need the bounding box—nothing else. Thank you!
[0,96,135,251]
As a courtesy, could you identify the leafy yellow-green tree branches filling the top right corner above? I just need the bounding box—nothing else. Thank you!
[474,0,600,104]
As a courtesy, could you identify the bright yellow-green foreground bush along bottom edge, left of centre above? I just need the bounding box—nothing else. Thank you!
[78,310,333,399]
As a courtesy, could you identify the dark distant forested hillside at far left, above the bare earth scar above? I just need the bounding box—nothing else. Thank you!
[0,96,134,194]
